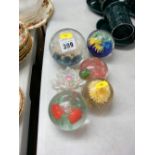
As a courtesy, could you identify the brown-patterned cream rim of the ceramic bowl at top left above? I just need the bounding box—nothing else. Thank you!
[20,0,54,30]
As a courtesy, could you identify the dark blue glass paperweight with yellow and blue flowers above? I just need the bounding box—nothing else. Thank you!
[87,30,114,57]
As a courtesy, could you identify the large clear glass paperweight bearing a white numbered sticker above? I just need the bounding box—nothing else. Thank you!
[50,28,87,66]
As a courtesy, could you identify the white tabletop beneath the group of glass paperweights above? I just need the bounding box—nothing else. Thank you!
[37,0,135,155]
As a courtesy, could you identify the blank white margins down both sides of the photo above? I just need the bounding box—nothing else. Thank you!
[0,0,155,155]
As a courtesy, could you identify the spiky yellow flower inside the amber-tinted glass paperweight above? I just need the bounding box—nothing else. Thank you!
[88,80,112,105]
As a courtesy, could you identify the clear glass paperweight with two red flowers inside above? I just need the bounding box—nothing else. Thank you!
[49,90,87,131]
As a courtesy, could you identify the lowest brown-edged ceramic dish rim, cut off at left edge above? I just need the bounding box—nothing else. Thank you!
[19,88,25,118]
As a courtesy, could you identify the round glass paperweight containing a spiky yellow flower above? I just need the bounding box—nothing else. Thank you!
[82,79,113,107]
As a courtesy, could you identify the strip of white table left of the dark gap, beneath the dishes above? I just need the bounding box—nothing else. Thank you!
[19,31,37,155]
